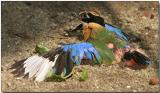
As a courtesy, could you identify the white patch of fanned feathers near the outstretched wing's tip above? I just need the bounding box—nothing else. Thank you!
[23,54,59,81]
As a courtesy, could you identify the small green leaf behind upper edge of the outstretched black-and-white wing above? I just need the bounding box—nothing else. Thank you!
[35,43,49,55]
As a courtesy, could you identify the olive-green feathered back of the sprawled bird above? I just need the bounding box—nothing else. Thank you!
[89,30,127,64]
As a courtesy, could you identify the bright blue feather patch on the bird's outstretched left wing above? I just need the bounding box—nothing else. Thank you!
[62,42,101,65]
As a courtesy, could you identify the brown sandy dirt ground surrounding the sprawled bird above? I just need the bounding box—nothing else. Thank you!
[1,2,158,92]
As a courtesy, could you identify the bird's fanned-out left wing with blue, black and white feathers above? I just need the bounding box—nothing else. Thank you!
[13,42,101,81]
